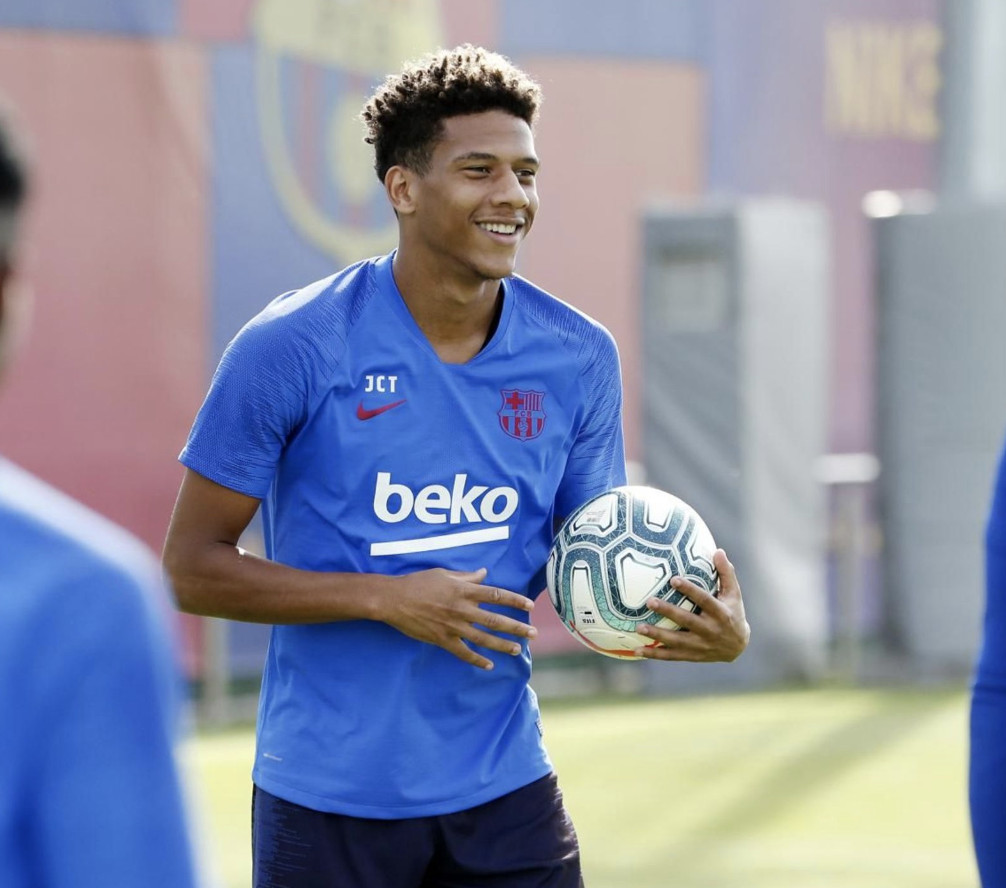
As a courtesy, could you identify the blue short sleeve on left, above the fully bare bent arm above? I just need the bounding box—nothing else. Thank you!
[179,314,310,499]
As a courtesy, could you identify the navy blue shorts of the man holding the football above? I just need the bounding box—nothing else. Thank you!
[252,774,583,888]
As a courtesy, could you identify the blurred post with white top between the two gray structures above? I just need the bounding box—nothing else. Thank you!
[817,454,880,683]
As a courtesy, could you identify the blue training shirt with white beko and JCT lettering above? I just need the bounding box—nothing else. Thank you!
[181,254,625,819]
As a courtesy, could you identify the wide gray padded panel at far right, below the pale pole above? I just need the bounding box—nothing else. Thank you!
[874,205,1006,672]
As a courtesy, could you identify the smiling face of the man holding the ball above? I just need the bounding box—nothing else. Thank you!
[389,111,538,284]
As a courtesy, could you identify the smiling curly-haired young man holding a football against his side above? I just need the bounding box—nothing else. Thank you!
[165,46,747,888]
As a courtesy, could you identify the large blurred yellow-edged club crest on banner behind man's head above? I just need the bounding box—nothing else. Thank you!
[251,0,444,263]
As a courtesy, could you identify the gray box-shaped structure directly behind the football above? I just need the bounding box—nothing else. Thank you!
[643,199,829,690]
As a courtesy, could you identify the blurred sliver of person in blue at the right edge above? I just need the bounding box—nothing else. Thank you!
[970,438,1006,888]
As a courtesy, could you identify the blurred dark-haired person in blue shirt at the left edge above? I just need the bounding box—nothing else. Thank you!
[0,107,194,888]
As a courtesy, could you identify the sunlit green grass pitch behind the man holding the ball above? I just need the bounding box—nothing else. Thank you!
[183,689,978,888]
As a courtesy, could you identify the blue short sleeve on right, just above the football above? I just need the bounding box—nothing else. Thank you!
[555,329,626,519]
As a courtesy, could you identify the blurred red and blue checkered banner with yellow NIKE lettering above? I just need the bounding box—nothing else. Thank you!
[0,0,943,667]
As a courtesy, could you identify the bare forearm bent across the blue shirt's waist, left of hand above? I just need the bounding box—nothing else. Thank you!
[164,543,395,624]
